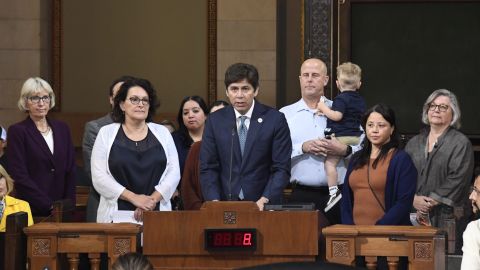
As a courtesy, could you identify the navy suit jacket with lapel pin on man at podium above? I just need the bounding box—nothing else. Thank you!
[200,101,292,203]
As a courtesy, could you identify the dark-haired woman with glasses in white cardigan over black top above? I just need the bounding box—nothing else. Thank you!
[91,79,180,223]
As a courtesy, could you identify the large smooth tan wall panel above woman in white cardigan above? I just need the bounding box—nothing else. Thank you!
[62,0,207,113]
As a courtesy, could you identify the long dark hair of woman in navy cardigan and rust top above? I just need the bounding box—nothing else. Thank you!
[353,103,399,169]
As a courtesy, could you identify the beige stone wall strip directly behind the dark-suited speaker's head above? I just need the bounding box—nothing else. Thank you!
[217,0,277,106]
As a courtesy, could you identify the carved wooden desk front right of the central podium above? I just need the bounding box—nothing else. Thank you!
[322,225,445,270]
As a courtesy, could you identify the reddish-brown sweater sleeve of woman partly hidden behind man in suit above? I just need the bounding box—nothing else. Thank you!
[180,142,204,210]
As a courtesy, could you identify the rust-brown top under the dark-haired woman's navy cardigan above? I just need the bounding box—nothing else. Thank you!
[350,152,392,225]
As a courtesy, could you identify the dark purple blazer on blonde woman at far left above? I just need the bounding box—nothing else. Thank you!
[7,117,75,216]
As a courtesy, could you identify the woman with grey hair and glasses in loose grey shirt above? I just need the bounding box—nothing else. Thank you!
[405,89,474,250]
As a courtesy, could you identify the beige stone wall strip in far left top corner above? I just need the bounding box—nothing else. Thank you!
[0,0,50,126]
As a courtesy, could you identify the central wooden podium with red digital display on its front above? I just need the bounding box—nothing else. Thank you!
[143,202,318,269]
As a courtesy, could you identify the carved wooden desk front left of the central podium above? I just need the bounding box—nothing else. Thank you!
[24,223,141,270]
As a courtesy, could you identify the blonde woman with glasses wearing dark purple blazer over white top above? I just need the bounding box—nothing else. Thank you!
[7,77,75,216]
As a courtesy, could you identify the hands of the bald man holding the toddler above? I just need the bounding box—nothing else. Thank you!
[302,136,347,156]
